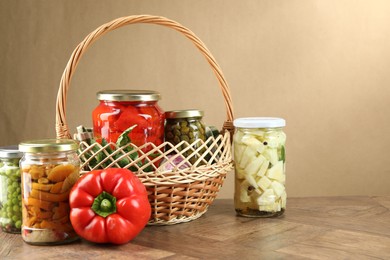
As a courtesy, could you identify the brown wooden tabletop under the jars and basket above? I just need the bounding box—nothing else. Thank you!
[0,197,390,260]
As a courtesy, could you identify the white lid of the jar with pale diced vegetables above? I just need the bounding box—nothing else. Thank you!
[233,117,286,128]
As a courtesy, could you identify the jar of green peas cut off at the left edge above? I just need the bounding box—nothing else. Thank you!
[0,146,23,233]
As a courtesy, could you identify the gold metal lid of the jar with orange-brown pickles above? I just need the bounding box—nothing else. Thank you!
[19,139,78,153]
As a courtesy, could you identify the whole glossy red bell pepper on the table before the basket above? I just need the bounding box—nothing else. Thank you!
[69,168,151,244]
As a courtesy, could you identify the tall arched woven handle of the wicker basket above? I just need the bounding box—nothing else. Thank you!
[56,15,234,139]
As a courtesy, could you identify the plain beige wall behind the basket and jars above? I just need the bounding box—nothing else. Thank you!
[0,0,390,198]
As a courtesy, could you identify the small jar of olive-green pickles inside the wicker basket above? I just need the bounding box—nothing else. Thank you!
[165,109,206,164]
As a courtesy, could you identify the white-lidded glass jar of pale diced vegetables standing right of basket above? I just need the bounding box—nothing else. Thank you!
[233,117,287,217]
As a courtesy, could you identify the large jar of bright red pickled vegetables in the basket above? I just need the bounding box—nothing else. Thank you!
[92,90,165,152]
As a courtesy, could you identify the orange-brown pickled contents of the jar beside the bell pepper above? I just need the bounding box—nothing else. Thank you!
[22,164,79,243]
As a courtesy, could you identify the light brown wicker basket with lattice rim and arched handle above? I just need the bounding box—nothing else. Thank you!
[56,15,233,225]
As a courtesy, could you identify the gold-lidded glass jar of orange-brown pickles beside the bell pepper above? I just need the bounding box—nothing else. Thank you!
[19,139,80,245]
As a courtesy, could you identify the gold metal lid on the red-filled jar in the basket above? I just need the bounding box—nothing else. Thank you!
[96,89,161,101]
